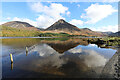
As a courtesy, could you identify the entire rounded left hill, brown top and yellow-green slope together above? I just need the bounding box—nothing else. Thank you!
[0,21,40,37]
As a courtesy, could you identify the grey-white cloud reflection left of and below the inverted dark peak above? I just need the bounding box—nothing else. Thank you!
[30,44,65,67]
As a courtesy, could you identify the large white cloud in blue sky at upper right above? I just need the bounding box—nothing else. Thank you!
[81,3,117,24]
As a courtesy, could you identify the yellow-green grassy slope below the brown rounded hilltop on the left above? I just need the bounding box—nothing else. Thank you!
[0,26,40,37]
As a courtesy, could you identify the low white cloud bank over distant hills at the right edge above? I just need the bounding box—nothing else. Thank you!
[90,25,118,32]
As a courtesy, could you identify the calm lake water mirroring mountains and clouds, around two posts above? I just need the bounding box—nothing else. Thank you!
[0,38,116,78]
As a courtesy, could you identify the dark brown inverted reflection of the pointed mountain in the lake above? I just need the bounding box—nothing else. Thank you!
[41,39,88,53]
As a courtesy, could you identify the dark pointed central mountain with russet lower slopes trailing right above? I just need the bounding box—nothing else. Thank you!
[45,19,104,36]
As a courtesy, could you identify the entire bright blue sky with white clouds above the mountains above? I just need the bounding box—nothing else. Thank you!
[0,2,118,32]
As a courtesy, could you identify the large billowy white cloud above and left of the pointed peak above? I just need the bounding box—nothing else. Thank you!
[31,2,70,28]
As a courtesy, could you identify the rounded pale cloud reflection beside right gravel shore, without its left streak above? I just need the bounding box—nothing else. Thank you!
[80,50,107,67]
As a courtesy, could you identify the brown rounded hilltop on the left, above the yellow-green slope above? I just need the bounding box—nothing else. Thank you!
[2,21,40,30]
